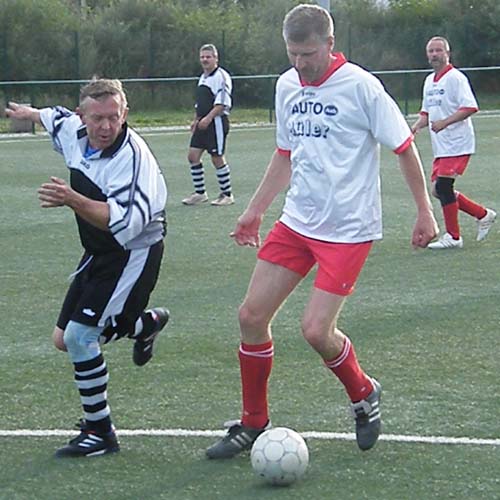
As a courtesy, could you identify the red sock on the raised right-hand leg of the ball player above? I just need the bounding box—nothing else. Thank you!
[325,337,373,402]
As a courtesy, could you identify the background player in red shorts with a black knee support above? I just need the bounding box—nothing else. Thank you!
[412,36,496,250]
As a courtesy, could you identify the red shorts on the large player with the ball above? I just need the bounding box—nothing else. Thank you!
[257,221,373,295]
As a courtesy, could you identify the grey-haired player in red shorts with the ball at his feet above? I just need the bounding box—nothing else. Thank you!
[207,4,437,458]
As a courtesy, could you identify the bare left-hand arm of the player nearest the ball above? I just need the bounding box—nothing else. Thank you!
[230,151,291,247]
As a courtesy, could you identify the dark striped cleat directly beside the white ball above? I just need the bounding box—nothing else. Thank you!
[206,420,271,458]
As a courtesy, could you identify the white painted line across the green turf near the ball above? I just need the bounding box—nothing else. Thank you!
[0,429,500,446]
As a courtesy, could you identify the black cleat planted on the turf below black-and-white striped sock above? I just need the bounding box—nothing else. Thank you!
[55,420,120,458]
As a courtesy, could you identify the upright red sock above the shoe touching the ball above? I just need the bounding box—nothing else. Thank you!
[238,340,274,429]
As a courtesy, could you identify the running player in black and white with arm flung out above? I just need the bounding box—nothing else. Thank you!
[6,79,168,457]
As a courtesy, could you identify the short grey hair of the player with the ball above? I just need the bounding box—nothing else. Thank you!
[283,4,334,43]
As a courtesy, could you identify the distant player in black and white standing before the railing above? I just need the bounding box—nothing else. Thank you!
[182,44,234,206]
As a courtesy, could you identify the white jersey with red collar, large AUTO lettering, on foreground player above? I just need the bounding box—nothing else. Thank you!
[275,53,413,243]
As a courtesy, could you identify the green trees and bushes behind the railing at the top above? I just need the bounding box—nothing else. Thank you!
[0,0,500,108]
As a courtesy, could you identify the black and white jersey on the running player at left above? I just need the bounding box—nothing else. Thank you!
[40,106,167,255]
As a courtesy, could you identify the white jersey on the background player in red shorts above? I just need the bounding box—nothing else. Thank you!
[421,64,479,158]
